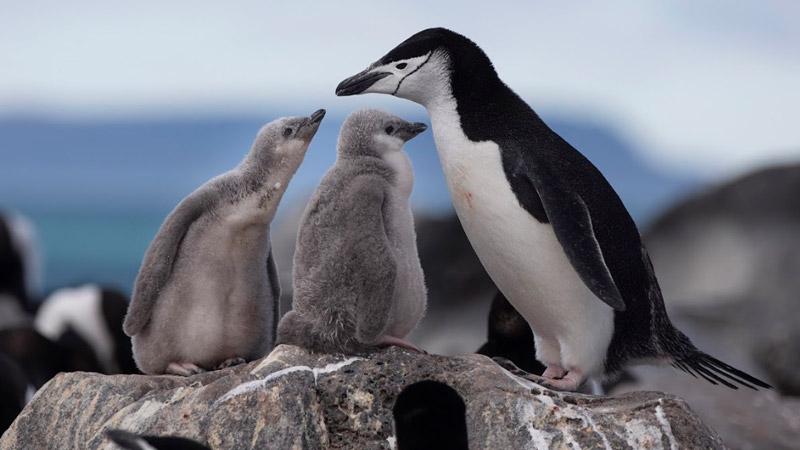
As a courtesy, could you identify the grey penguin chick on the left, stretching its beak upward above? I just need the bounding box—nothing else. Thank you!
[123,110,325,376]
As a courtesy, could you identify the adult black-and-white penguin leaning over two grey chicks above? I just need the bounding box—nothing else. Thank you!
[336,28,769,390]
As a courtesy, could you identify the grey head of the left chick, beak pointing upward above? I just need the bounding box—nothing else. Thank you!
[253,109,325,163]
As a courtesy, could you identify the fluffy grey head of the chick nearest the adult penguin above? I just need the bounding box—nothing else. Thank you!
[339,109,427,158]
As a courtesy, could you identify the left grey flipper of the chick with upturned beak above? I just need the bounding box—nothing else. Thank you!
[122,184,216,336]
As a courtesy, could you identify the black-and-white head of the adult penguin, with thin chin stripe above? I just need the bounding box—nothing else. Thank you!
[336,28,497,106]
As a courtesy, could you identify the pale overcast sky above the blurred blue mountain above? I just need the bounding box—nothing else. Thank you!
[0,0,800,174]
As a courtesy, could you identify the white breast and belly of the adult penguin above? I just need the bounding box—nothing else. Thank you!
[429,97,613,372]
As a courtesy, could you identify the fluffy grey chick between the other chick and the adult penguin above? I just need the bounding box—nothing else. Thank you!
[278,110,426,353]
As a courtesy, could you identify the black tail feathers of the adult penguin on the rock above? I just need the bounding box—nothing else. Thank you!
[671,350,772,391]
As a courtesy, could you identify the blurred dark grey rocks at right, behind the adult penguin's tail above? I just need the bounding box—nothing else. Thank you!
[617,165,800,449]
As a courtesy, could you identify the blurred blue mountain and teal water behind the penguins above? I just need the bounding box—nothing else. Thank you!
[0,114,698,290]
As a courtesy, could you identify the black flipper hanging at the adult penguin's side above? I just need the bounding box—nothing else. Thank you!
[533,180,626,311]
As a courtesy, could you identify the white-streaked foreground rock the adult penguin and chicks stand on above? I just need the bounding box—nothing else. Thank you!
[0,345,723,449]
